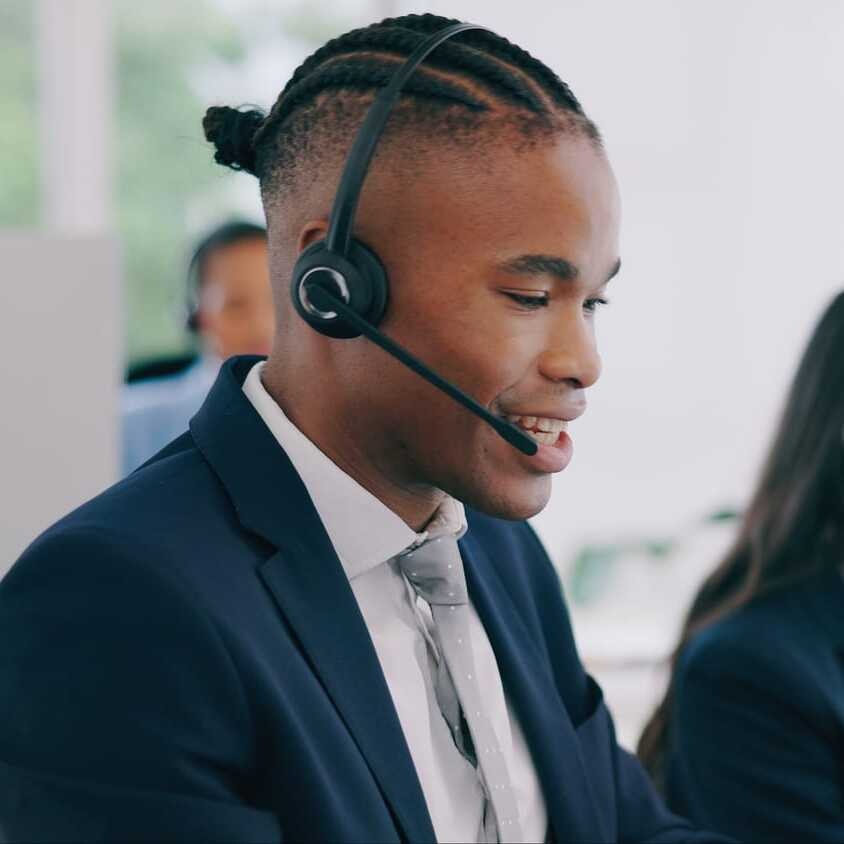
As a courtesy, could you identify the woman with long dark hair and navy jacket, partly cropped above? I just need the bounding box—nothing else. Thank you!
[638,293,844,842]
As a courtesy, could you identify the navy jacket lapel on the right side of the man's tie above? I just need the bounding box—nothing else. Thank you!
[460,532,611,842]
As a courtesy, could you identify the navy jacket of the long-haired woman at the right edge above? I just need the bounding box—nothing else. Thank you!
[666,572,844,842]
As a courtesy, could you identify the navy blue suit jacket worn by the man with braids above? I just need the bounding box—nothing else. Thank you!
[0,358,715,842]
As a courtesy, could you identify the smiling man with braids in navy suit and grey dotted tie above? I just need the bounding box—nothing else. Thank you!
[0,15,714,842]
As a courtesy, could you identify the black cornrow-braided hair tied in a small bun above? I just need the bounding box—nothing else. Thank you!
[203,14,601,189]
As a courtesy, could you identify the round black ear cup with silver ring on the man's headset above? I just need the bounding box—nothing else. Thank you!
[290,241,388,339]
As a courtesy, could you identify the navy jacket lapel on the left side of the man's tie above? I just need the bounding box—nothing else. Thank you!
[191,358,435,841]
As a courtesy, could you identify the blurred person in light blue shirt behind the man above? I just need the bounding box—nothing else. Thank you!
[121,220,274,475]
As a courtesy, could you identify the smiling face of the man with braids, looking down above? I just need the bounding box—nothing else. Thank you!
[304,130,619,519]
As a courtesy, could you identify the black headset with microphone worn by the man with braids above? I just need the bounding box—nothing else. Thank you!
[290,23,538,455]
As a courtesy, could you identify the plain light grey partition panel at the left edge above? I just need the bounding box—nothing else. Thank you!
[0,232,123,576]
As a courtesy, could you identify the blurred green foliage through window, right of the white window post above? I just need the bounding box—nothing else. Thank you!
[114,0,251,359]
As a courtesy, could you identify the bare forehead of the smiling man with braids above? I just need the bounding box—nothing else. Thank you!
[380,134,620,273]
